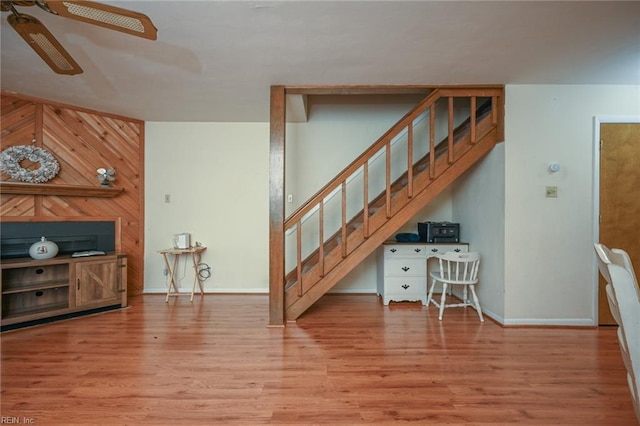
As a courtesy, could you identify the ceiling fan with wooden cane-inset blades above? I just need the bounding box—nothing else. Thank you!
[0,0,158,75]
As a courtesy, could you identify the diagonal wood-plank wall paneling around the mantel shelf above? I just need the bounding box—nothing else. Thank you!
[1,93,144,295]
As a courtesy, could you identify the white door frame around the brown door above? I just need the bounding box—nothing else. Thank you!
[591,115,640,327]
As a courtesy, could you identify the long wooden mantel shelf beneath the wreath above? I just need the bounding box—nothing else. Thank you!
[0,182,123,198]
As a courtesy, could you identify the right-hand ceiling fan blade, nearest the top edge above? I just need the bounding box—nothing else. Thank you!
[42,1,158,40]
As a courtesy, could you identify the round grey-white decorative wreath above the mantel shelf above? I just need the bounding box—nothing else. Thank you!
[0,145,60,183]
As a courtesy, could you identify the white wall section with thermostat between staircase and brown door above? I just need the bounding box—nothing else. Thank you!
[504,85,640,325]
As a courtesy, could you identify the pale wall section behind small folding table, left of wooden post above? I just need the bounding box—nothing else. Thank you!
[144,122,269,292]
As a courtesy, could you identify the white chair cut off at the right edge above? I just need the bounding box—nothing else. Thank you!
[594,243,640,423]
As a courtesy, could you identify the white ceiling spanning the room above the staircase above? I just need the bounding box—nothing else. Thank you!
[0,1,640,122]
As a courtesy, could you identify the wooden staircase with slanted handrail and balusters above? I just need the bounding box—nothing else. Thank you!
[270,87,504,325]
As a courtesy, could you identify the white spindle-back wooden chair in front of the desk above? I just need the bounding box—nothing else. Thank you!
[427,252,484,322]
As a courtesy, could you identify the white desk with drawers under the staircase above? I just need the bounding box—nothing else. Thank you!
[378,242,469,305]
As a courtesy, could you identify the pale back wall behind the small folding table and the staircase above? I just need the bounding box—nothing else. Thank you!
[145,98,452,293]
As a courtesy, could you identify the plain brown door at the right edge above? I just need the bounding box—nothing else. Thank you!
[598,123,640,325]
